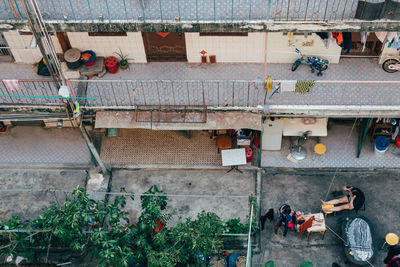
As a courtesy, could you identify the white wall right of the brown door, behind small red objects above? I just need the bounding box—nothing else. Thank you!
[185,32,265,63]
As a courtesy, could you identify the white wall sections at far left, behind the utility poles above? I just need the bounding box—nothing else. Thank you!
[3,31,62,64]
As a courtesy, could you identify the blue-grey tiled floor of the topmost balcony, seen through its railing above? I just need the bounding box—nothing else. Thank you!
[0,0,357,22]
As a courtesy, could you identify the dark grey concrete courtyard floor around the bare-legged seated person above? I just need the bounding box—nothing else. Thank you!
[253,170,400,267]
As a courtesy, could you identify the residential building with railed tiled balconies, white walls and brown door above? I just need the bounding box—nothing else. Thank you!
[0,0,400,170]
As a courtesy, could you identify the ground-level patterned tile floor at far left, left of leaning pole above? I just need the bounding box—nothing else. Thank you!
[0,126,91,165]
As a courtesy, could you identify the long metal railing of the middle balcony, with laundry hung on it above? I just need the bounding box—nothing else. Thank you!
[0,80,400,110]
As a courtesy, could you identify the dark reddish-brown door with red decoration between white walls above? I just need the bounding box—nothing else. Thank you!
[142,32,187,62]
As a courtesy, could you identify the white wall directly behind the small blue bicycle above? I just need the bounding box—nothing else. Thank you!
[267,32,342,64]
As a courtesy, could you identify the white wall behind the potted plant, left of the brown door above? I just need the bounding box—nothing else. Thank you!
[68,32,147,63]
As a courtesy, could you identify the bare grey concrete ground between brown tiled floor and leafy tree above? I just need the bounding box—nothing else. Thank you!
[108,170,256,226]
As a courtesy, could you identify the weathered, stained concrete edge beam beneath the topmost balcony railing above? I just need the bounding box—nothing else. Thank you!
[0,19,400,32]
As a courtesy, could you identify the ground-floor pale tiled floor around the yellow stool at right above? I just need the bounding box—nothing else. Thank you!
[261,125,400,168]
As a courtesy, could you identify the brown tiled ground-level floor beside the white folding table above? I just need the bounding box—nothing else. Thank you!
[101,129,222,166]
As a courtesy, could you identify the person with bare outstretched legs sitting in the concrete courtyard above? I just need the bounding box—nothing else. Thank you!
[321,186,365,212]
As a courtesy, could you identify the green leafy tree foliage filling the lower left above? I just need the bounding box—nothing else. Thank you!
[0,185,256,267]
